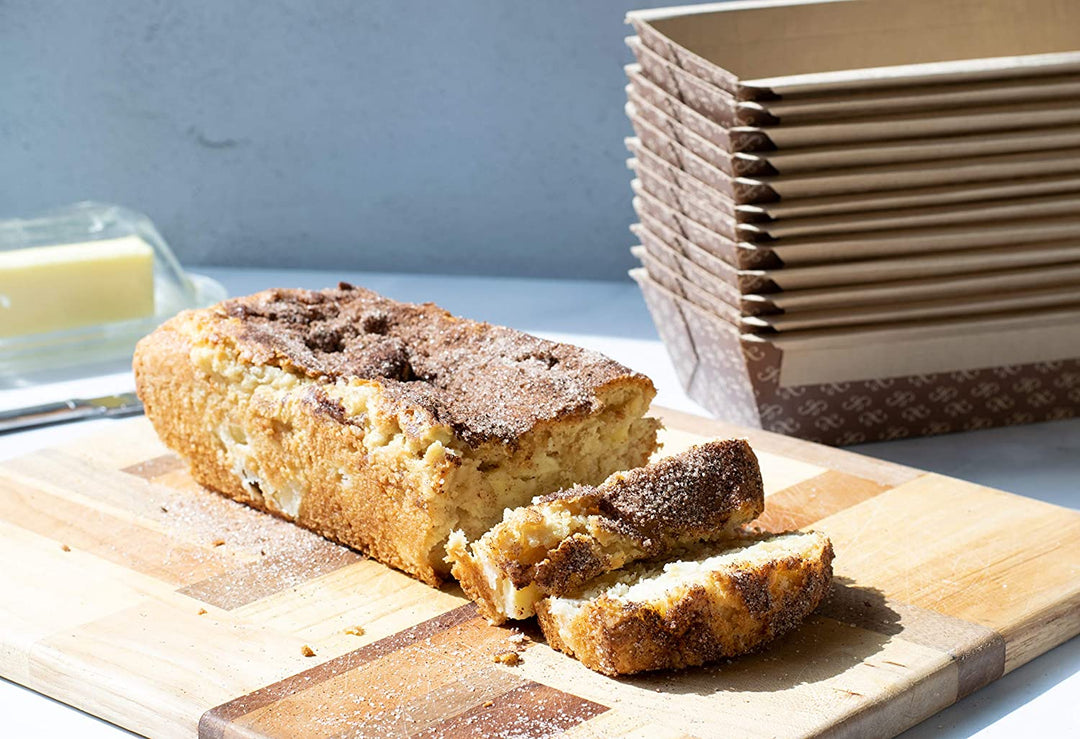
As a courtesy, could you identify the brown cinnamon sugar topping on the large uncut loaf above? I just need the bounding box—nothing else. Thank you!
[215,283,645,443]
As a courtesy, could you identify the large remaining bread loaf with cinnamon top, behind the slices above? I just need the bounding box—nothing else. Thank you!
[134,283,659,585]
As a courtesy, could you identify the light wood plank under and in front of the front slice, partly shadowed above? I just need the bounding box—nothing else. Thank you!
[523,617,957,737]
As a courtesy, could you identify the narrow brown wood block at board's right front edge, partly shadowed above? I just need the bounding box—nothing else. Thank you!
[818,578,1005,700]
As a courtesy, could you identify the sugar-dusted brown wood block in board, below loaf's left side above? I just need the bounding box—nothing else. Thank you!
[179,542,364,610]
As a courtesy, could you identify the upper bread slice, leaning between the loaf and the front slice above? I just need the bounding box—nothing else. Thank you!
[446,439,765,623]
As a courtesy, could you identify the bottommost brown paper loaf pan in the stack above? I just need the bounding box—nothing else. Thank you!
[631,269,1080,445]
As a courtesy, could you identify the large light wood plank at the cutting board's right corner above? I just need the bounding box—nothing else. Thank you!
[814,474,1080,670]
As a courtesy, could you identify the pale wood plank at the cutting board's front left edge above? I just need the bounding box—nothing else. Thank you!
[30,595,311,737]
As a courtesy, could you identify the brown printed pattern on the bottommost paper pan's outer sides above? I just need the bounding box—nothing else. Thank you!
[638,276,1080,445]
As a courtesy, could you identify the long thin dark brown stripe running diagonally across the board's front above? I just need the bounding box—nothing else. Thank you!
[199,603,477,739]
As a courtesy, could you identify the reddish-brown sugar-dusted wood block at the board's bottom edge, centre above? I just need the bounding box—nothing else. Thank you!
[413,682,608,739]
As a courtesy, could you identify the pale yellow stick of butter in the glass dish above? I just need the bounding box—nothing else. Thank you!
[0,236,154,337]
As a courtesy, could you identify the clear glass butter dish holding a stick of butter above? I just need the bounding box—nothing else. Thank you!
[0,202,225,379]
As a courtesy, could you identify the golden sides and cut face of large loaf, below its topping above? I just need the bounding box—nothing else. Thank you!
[134,288,657,585]
